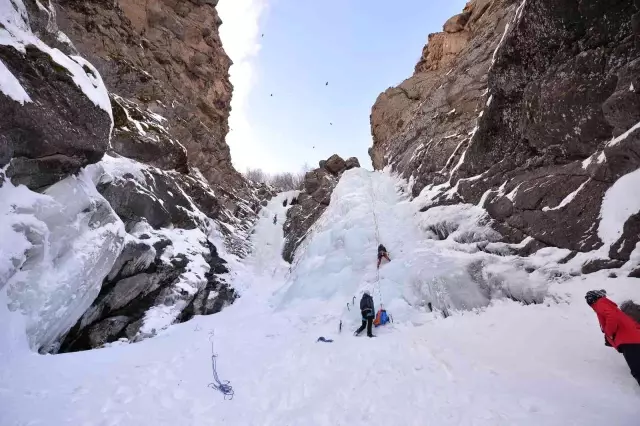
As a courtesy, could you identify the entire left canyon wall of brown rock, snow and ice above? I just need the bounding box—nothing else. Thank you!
[0,0,273,352]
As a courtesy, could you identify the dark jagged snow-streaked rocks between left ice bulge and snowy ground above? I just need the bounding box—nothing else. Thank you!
[61,156,258,351]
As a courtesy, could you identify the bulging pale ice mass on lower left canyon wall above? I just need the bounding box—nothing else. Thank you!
[0,171,125,351]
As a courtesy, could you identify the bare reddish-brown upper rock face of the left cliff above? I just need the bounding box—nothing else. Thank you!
[57,0,241,186]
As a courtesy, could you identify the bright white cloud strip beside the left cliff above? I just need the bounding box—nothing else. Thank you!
[217,0,269,171]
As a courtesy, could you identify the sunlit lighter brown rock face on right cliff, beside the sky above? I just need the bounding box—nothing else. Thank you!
[369,0,515,173]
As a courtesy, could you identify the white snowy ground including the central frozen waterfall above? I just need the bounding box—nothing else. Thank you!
[0,169,640,426]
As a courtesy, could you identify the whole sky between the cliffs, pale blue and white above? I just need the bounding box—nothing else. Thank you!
[218,0,466,173]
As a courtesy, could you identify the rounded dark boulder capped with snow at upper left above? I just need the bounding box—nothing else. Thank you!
[0,0,113,188]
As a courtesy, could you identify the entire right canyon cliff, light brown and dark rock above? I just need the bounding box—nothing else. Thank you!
[370,0,640,272]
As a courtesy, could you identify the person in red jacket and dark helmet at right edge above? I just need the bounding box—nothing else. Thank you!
[585,290,640,385]
